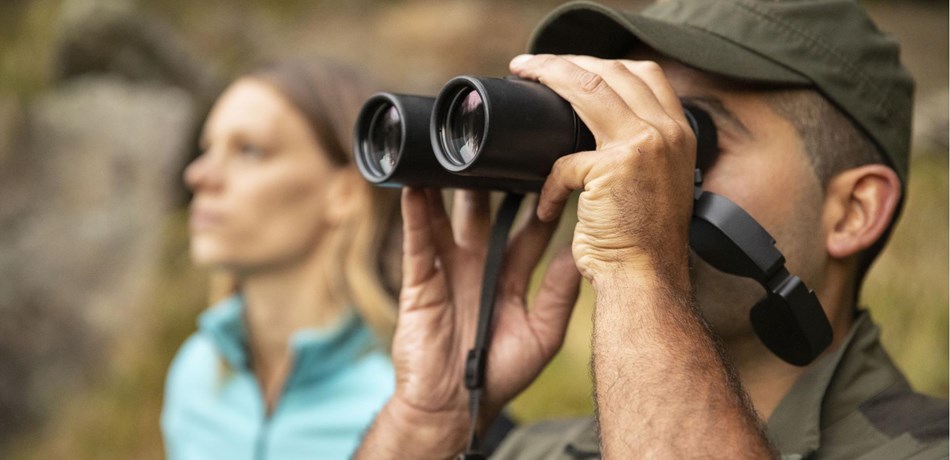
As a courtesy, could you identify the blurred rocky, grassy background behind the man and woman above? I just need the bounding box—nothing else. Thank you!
[0,0,948,459]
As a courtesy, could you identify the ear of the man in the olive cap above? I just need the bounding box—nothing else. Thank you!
[822,164,901,259]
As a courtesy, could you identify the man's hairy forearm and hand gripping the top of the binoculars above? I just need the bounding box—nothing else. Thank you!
[511,55,771,458]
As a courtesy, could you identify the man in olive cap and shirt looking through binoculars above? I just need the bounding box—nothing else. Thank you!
[357,0,947,459]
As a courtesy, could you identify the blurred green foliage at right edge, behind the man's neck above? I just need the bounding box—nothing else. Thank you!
[862,152,950,398]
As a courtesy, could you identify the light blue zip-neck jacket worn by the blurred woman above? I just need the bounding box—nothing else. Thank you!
[162,296,394,460]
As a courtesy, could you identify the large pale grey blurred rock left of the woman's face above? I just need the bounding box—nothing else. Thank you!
[0,76,196,444]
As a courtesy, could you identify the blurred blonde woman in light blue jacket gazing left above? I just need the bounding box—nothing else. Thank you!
[162,62,399,459]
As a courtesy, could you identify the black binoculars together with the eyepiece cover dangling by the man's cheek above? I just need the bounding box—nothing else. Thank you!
[354,76,831,366]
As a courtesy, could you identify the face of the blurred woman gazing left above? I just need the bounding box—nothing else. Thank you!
[185,78,334,274]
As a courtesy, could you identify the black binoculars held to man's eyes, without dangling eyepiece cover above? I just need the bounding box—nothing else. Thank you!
[353,76,716,193]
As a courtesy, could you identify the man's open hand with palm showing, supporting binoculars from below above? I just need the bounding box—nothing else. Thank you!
[357,189,580,459]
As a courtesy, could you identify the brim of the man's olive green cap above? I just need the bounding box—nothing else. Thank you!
[528,2,810,85]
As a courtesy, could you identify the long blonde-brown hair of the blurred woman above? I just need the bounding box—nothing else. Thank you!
[210,60,401,344]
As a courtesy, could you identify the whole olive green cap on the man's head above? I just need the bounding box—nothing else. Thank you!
[529,0,914,183]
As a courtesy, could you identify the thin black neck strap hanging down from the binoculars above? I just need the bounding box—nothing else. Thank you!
[459,193,524,460]
